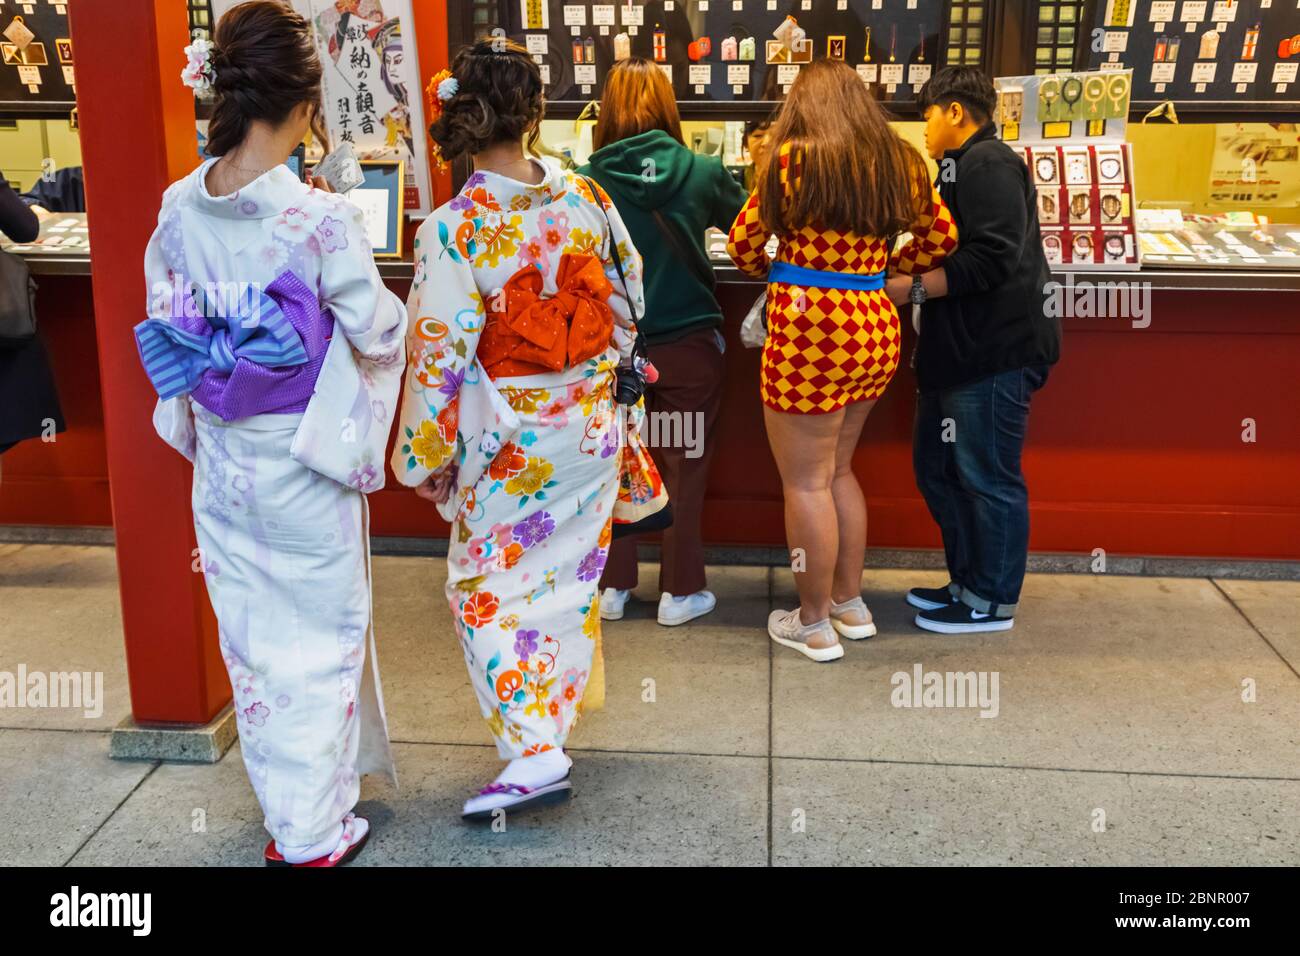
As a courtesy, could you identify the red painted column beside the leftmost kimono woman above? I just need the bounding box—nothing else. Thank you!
[69,0,230,723]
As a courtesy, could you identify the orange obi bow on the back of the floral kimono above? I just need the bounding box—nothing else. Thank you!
[478,252,614,378]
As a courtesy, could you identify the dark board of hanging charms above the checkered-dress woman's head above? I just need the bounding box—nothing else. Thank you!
[450,0,988,117]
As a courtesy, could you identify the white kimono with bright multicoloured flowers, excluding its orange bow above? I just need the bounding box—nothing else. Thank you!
[391,165,642,760]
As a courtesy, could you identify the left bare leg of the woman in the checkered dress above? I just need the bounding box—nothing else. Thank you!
[763,406,844,624]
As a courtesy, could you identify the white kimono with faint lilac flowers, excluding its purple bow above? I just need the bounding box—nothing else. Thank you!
[144,161,406,847]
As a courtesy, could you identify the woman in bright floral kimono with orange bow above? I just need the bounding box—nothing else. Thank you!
[393,39,641,819]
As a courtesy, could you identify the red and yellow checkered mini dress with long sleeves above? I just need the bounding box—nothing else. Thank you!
[727,143,957,414]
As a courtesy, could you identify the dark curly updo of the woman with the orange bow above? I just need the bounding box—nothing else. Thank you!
[429,36,546,163]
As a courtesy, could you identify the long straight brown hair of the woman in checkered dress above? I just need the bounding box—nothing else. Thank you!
[758,60,930,237]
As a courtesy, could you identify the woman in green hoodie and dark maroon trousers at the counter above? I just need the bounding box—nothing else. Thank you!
[579,57,748,626]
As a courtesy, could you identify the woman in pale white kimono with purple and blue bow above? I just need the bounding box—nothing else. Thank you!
[135,0,406,866]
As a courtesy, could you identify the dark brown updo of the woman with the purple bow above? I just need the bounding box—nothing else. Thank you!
[207,0,329,156]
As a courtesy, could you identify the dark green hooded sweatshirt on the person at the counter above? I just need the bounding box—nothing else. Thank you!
[579,130,749,345]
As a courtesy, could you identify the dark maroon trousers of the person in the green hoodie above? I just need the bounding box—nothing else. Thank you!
[601,329,723,596]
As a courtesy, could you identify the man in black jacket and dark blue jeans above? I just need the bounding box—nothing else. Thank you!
[887,66,1061,633]
